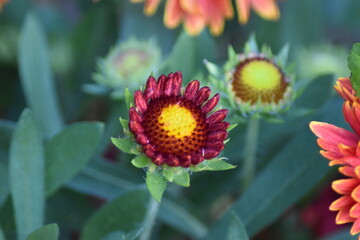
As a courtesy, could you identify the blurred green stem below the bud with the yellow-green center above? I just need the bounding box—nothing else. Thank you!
[242,117,260,191]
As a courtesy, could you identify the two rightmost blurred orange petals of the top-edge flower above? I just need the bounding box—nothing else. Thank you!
[236,0,280,24]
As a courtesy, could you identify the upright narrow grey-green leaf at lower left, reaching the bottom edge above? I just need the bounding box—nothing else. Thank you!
[9,109,45,240]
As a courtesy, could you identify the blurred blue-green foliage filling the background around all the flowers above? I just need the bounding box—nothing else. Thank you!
[0,0,360,240]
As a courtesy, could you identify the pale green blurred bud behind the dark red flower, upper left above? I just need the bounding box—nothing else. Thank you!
[93,38,161,96]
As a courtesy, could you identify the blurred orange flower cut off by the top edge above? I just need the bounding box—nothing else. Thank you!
[130,0,280,35]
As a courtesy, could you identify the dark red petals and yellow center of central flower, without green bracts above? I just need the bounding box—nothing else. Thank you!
[129,72,229,168]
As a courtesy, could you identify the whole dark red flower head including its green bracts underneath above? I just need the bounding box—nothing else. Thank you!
[112,72,235,200]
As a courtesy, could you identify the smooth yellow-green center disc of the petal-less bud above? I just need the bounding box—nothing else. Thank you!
[242,61,282,90]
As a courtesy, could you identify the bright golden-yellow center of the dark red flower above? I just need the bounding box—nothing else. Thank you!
[158,104,196,139]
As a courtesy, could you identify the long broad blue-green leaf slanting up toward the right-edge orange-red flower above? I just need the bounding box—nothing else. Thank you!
[206,99,342,239]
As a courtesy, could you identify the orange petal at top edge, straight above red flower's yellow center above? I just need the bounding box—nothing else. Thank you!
[164,0,184,28]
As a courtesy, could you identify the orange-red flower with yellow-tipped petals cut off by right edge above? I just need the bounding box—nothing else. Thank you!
[310,78,360,235]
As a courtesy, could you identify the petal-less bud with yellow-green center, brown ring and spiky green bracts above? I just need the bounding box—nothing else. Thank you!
[205,38,295,116]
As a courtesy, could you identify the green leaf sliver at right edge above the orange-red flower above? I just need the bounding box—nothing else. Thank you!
[348,43,360,97]
